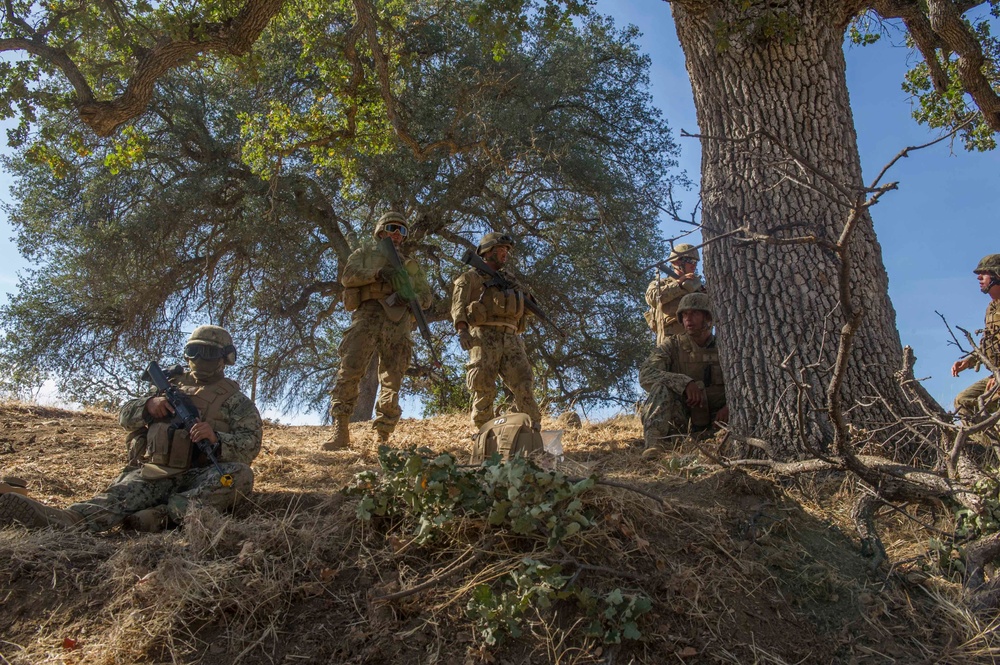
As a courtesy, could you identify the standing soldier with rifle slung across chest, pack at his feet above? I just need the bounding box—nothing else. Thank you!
[451,233,542,430]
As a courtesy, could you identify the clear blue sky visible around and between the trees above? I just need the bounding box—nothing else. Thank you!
[0,0,1000,422]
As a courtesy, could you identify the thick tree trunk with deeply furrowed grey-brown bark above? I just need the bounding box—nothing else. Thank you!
[671,0,911,458]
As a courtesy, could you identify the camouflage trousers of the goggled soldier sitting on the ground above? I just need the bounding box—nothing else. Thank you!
[69,462,253,531]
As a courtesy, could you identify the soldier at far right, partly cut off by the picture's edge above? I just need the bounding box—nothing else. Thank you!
[951,254,1000,422]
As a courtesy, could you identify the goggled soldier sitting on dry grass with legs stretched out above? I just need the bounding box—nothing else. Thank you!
[0,326,263,532]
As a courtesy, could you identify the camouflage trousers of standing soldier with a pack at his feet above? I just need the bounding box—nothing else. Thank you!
[465,326,542,430]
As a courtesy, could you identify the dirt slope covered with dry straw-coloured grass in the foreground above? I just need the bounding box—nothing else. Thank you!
[0,404,993,664]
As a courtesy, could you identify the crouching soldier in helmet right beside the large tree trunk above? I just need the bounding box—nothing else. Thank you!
[639,293,729,448]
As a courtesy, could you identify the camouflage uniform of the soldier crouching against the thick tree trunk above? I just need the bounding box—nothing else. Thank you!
[639,334,726,447]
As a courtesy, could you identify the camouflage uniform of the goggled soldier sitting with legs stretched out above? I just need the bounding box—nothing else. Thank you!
[69,374,263,531]
